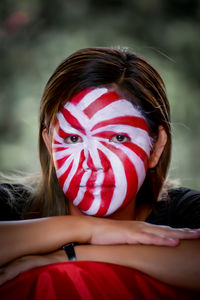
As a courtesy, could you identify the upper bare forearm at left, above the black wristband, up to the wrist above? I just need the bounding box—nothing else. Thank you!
[0,216,90,265]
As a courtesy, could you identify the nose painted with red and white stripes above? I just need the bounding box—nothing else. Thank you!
[83,149,109,172]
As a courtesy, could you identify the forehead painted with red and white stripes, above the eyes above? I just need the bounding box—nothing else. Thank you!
[58,88,148,130]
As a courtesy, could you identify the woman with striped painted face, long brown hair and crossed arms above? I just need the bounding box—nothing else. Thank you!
[0,48,200,290]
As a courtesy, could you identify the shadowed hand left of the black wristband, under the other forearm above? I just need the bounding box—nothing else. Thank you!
[0,250,67,285]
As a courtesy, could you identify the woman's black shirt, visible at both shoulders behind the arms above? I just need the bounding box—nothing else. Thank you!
[0,184,200,229]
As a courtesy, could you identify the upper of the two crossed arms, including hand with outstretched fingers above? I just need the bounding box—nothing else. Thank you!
[0,216,200,265]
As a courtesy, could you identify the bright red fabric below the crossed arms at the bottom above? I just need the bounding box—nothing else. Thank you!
[0,261,200,300]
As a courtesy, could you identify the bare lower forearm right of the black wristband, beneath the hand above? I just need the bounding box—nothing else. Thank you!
[76,240,200,291]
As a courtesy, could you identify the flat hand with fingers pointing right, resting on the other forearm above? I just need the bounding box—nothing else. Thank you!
[89,218,200,246]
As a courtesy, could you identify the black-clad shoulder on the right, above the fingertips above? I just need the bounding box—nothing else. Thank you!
[146,187,200,228]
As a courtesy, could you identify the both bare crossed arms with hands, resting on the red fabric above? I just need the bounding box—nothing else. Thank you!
[0,216,200,291]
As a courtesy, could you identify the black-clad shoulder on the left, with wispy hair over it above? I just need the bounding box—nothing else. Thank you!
[0,183,30,221]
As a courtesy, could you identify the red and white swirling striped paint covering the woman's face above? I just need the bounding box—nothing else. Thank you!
[53,88,151,216]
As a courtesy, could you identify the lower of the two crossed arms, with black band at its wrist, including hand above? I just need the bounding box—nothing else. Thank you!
[0,240,200,291]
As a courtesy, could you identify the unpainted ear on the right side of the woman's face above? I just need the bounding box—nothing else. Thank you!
[149,126,167,168]
